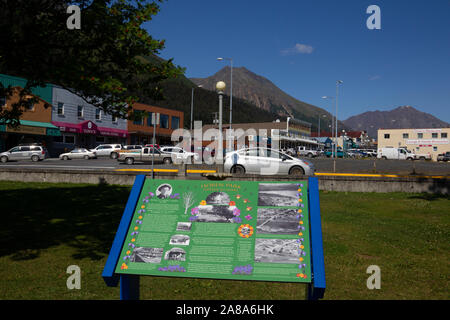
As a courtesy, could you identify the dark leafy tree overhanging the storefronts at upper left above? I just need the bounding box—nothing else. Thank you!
[0,0,184,126]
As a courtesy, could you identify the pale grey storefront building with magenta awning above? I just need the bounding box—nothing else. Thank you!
[51,86,128,153]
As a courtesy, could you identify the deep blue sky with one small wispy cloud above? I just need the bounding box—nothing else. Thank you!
[145,0,450,122]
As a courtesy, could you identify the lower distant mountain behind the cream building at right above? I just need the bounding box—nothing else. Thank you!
[343,106,450,138]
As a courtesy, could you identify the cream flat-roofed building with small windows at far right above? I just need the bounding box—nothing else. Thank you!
[378,128,450,161]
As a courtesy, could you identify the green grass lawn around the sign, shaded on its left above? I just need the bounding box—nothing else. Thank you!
[0,181,450,300]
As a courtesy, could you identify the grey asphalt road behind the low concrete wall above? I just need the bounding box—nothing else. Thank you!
[0,158,450,175]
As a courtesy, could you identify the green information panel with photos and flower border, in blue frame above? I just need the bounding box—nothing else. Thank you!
[114,178,311,283]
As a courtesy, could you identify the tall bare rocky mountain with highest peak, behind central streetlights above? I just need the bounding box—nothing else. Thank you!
[190,66,344,130]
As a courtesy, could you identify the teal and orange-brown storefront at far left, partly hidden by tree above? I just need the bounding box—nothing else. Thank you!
[0,75,61,152]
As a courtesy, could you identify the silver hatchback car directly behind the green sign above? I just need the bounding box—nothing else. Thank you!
[224,148,316,176]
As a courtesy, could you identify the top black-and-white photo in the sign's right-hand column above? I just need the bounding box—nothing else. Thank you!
[258,183,298,207]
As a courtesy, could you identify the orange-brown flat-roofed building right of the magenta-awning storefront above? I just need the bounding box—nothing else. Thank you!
[128,103,184,145]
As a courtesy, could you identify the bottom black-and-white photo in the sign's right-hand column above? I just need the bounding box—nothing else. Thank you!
[255,238,300,263]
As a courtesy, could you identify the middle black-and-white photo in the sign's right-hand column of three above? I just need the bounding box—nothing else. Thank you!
[256,208,299,234]
